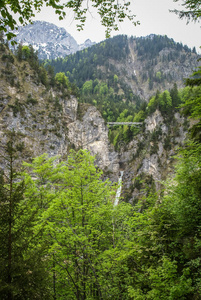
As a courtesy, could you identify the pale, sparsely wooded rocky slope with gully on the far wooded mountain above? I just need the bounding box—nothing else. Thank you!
[110,35,200,101]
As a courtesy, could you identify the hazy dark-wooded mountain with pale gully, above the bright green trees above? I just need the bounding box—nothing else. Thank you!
[48,35,200,101]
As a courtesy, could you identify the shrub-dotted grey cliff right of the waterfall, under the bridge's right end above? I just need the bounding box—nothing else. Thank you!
[119,110,189,203]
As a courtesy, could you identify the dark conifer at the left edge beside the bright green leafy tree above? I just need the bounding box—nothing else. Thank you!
[0,132,50,300]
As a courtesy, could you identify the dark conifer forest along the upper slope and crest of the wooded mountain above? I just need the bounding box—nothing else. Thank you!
[45,35,196,88]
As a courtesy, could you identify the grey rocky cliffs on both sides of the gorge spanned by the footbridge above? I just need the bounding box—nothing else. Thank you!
[0,40,190,203]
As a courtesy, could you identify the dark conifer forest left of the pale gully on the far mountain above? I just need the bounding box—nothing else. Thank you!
[46,35,129,88]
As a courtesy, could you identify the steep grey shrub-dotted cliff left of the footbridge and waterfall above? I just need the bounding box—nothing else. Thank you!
[0,44,118,172]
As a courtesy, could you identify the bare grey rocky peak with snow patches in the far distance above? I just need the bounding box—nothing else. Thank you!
[11,21,94,59]
